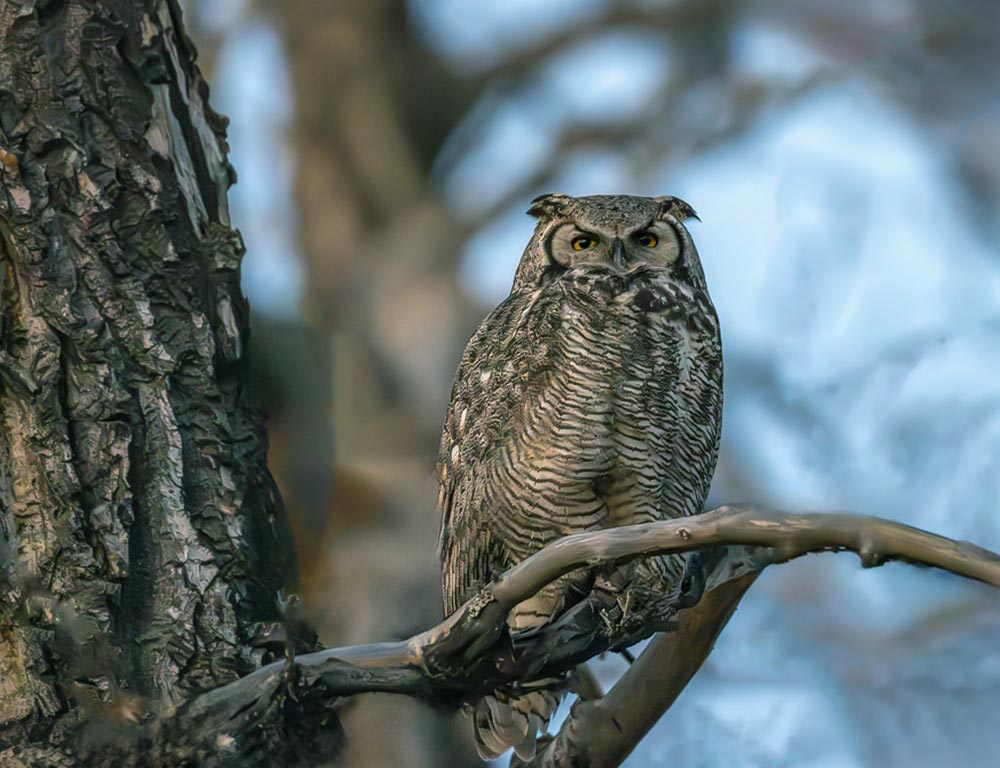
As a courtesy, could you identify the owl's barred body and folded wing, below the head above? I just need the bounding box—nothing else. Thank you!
[438,266,722,613]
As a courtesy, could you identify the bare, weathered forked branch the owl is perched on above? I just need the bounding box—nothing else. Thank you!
[157,506,1000,765]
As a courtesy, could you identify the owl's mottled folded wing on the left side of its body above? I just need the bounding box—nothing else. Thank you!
[437,284,552,614]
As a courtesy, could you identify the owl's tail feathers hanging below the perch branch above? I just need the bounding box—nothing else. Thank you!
[472,690,562,760]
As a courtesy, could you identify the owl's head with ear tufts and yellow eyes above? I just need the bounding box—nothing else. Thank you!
[513,194,705,291]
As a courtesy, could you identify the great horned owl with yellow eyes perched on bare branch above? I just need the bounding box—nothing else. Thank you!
[438,194,722,758]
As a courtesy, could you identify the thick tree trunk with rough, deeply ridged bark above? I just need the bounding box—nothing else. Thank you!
[0,0,294,765]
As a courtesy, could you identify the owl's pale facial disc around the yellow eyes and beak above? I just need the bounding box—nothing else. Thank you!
[549,220,681,269]
